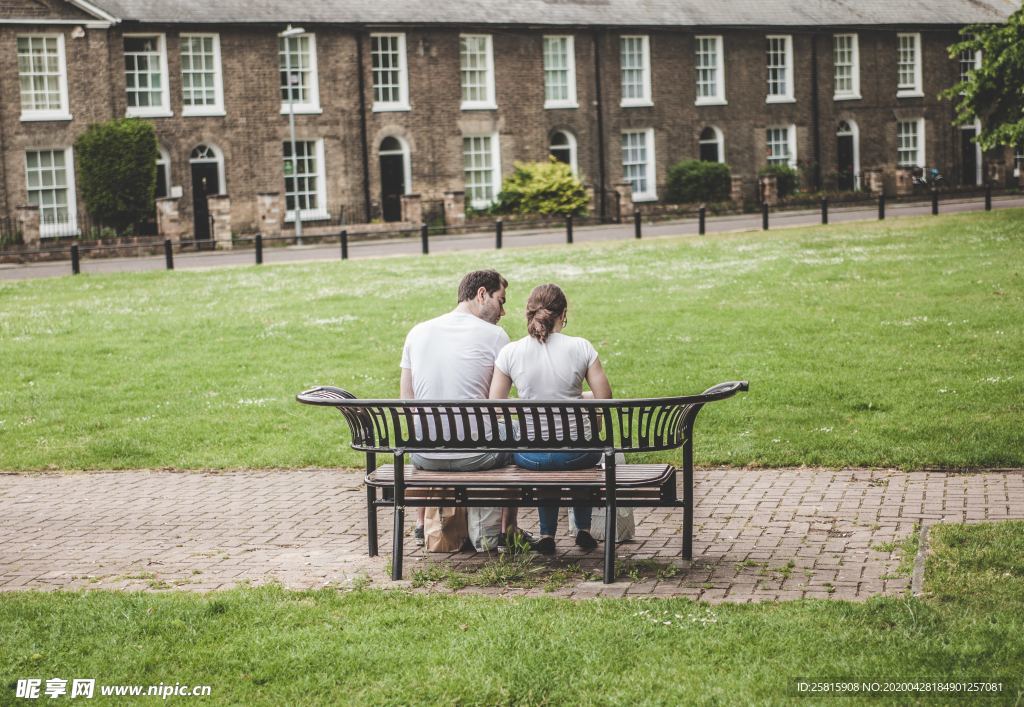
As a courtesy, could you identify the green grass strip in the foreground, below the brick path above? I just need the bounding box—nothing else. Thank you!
[0,523,1024,705]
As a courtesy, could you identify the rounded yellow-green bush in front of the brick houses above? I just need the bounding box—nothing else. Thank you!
[494,157,590,215]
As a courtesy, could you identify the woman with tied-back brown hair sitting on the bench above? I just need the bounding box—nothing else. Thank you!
[488,285,611,554]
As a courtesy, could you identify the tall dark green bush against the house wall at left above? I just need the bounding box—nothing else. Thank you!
[75,118,159,236]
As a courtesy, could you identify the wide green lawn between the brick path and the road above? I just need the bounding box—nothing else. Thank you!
[0,210,1024,469]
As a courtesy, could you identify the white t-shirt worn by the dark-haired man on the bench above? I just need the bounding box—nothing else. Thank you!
[401,311,509,450]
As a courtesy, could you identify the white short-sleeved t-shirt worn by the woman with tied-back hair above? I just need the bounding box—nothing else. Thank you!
[495,333,597,436]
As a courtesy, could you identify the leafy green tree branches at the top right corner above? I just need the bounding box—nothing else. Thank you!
[941,7,1024,150]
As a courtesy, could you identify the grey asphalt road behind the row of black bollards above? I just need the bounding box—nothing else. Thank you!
[0,196,1024,280]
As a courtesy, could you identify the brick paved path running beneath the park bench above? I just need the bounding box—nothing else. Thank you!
[0,469,1024,601]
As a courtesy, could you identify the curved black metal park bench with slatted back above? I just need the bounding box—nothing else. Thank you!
[297,381,748,583]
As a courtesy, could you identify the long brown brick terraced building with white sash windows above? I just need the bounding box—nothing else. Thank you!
[0,0,1024,238]
